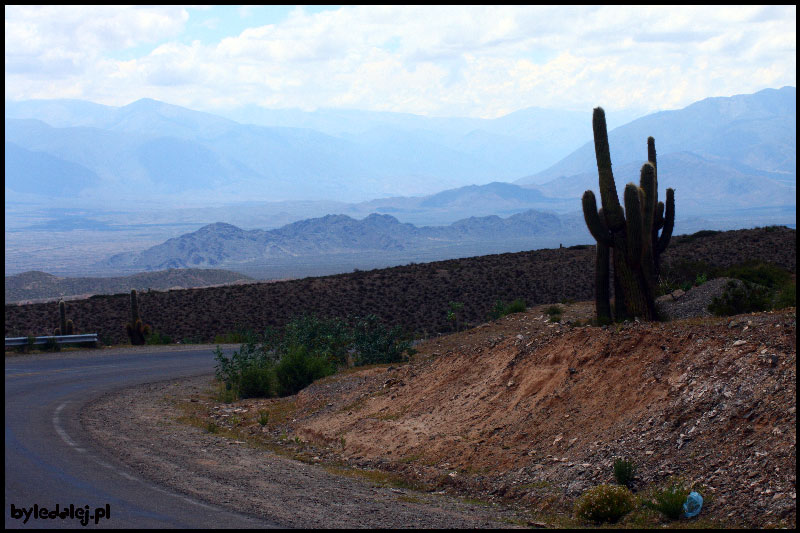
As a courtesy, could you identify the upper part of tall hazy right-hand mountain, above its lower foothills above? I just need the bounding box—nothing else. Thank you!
[515,87,797,191]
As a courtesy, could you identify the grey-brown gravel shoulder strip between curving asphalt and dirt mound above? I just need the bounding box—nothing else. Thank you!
[81,376,524,528]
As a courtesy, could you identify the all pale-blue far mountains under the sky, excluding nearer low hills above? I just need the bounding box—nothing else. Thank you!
[5,87,797,213]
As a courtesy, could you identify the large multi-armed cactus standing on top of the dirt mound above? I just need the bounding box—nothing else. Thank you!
[583,107,675,323]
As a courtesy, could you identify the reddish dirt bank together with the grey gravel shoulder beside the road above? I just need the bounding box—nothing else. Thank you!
[84,302,797,527]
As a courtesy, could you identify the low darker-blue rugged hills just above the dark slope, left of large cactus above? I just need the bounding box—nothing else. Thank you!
[96,210,589,270]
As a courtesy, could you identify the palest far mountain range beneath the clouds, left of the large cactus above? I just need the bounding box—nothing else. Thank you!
[5,99,612,202]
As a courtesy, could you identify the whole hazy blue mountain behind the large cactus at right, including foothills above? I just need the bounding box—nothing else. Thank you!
[514,87,797,213]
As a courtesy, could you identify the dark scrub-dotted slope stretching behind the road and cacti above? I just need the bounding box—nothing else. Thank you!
[5,227,797,343]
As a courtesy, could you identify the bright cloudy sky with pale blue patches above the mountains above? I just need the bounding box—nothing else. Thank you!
[5,5,797,118]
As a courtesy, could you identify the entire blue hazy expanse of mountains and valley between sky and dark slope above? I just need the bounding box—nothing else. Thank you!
[5,87,797,277]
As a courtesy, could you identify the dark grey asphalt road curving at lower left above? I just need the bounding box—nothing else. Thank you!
[5,347,279,529]
